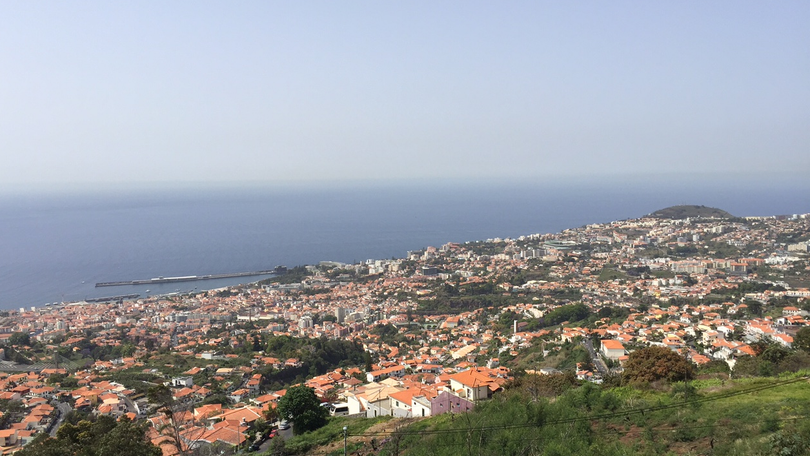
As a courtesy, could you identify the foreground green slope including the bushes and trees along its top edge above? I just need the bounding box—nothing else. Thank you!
[271,332,810,456]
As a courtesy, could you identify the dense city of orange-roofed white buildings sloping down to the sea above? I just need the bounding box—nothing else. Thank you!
[0,208,810,456]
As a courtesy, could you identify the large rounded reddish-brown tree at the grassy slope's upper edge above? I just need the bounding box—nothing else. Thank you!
[622,346,694,383]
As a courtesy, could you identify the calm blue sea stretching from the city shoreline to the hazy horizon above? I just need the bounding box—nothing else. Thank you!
[0,177,810,309]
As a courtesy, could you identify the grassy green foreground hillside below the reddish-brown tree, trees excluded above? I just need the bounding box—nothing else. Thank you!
[313,373,810,456]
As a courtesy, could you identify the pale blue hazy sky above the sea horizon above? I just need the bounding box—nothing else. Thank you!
[0,0,810,186]
